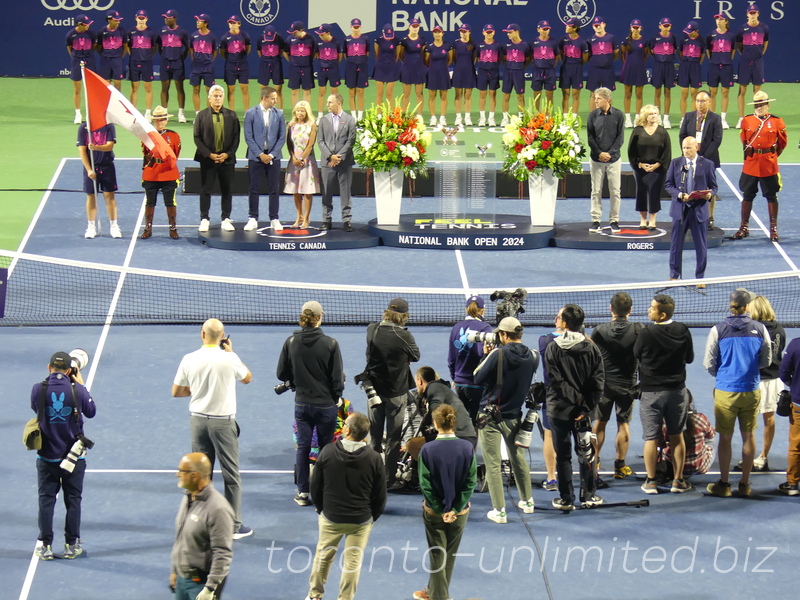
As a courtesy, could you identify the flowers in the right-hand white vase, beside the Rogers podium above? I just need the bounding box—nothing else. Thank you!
[503,102,586,181]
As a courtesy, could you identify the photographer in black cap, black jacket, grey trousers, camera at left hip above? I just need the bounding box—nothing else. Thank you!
[358,298,419,488]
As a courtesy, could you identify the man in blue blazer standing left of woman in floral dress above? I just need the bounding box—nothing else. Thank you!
[244,87,286,231]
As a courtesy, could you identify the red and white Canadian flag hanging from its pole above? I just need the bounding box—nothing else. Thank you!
[83,69,177,163]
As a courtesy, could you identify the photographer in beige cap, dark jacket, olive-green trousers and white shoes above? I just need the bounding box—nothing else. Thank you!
[474,317,539,523]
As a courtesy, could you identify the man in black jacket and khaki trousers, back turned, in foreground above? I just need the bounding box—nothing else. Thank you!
[308,412,386,600]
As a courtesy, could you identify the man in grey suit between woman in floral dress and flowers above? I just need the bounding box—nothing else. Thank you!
[317,94,356,231]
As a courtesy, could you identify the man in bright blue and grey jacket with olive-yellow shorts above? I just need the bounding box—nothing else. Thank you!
[703,288,772,498]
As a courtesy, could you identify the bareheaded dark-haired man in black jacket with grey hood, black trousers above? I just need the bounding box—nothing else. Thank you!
[544,304,605,510]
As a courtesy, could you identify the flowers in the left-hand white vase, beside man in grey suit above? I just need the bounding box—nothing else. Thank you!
[353,98,431,178]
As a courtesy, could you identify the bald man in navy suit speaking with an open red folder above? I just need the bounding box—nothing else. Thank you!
[664,137,717,287]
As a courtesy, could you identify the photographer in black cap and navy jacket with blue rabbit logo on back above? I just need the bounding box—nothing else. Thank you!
[31,352,96,560]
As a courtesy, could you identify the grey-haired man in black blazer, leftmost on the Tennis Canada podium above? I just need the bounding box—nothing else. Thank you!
[194,85,240,231]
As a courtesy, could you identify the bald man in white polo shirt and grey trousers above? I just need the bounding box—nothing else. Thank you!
[172,319,253,539]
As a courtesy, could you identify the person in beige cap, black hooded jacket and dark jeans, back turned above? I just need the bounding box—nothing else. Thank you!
[277,300,344,506]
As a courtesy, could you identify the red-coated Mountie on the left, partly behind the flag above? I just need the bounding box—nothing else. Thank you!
[141,106,181,240]
